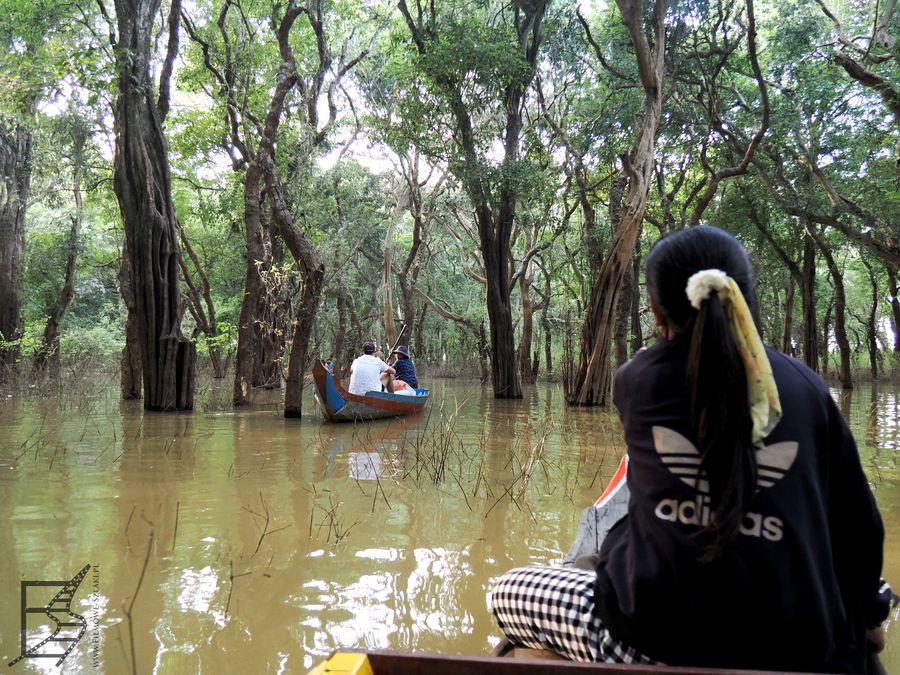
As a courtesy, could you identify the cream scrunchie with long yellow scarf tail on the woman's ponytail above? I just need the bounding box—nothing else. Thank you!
[685,269,781,444]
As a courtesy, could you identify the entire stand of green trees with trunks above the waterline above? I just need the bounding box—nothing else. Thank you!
[0,0,900,406]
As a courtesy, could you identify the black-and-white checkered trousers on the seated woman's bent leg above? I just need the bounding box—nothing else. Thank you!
[491,566,655,663]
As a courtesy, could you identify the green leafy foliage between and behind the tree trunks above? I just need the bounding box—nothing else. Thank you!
[0,0,900,386]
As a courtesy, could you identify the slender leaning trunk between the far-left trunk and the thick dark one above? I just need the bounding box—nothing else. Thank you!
[34,134,87,377]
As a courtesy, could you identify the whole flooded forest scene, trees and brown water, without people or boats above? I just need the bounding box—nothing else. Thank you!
[0,0,900,674]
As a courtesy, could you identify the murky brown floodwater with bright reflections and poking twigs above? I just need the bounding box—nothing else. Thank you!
[0,381,900,674]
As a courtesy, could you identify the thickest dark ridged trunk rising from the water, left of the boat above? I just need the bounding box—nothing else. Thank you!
[113,0,195,410]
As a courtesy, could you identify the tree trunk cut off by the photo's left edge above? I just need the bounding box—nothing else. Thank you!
[0,117,33,370]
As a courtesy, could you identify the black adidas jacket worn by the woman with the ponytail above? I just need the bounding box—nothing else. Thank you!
[595,340,887,673]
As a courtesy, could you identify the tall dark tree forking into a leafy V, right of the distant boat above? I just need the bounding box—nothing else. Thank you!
[399,0,547,398]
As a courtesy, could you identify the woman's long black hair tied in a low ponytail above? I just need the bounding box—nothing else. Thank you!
[647,227,757,560]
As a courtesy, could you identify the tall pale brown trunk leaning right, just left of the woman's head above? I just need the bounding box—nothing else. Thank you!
[569,0,665,405]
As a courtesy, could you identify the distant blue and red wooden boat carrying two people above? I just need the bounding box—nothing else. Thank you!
[313,359,431,422]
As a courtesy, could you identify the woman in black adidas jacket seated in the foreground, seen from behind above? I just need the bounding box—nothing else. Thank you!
[491,227,890,673]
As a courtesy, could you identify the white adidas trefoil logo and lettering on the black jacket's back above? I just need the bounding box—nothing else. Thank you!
[653,426,799,541]
